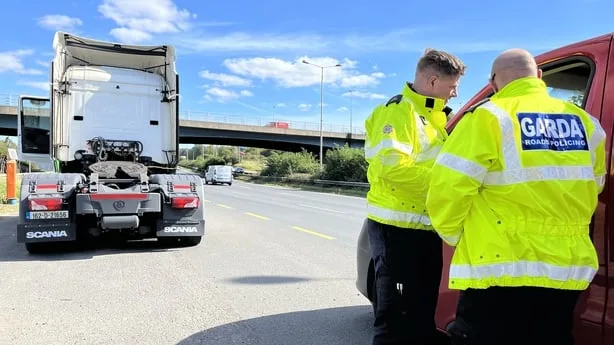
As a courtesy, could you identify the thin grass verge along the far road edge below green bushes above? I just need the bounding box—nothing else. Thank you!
[235,175,369,197]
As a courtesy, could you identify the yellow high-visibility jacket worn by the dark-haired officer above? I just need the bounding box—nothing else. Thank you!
[365,84,451,230]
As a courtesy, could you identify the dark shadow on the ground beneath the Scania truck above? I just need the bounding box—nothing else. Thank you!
[0,216,179,262]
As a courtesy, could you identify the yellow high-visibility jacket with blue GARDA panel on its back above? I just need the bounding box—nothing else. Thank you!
[426,77,606,290]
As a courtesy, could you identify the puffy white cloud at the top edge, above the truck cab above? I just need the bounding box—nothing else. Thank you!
[98,0,196,43]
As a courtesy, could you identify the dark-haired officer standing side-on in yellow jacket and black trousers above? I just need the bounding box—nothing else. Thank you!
[365,50,465,345]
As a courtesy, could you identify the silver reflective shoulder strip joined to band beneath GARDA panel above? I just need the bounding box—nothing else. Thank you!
[482,102,595,185]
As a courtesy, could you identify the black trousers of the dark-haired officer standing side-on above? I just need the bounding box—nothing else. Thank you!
[368,220,443,345]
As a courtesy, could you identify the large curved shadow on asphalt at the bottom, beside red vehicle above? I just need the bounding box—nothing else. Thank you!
[177,305,373,345]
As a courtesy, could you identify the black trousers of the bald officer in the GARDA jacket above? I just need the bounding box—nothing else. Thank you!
[450,287,581,345]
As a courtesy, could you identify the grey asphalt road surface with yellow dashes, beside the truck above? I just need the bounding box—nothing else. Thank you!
[0,177,372,345]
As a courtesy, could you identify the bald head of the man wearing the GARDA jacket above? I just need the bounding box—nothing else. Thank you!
[491,48,541,89]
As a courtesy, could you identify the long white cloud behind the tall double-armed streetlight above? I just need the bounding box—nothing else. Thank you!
[224,57,383,88]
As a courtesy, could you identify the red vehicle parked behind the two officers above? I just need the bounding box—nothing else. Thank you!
[356,34,614,345]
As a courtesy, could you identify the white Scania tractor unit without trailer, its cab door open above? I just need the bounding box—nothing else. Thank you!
[17,32,205,252]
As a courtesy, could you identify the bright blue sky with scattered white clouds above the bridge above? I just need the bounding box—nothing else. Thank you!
[0,0,614,134]
